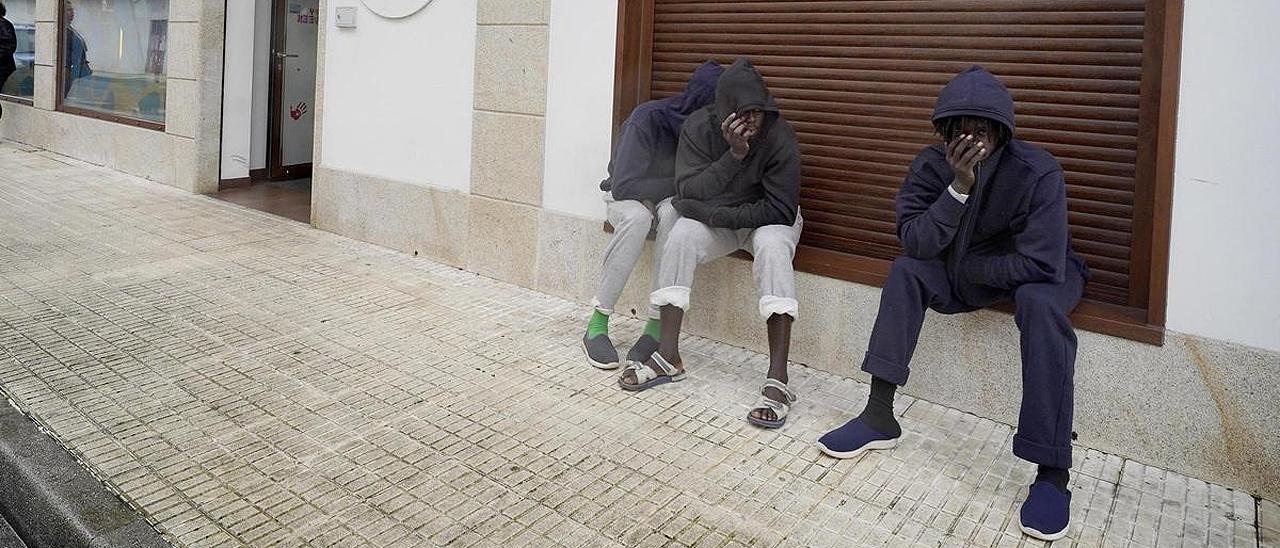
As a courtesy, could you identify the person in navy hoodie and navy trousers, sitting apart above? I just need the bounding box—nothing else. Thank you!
[818,67,1088,540]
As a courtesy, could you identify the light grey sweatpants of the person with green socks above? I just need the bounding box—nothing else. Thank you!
[593,192,680,319]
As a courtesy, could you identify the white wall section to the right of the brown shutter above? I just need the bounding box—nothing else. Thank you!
[1167,0,1280,351]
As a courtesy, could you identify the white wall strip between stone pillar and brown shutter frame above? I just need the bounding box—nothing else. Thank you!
[543,0,618,220]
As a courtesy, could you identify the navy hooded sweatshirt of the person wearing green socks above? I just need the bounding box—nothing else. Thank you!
[600,61,724,204]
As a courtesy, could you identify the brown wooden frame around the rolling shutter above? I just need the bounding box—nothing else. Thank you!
[613,0,1184,346]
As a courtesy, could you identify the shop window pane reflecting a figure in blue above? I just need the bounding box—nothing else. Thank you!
[60,0,169,123]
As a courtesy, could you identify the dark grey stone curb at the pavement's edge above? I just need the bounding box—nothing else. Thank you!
[0,402,170,548]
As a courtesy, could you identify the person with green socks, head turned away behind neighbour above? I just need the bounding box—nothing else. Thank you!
[582,61,724,369]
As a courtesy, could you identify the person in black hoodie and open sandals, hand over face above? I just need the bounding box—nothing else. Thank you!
[618,59,804,428]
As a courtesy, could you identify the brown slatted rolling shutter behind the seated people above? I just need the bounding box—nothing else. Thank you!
[618,0,1180,343]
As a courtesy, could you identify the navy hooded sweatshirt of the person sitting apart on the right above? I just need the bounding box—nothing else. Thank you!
[896,67,1087,306]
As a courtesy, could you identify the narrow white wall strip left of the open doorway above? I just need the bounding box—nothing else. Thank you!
[220,3,255,179]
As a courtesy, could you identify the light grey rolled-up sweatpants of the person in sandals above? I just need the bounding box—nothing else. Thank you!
[649,211,804,320]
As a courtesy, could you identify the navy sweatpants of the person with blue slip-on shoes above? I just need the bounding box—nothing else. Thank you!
[863,257,1084,469]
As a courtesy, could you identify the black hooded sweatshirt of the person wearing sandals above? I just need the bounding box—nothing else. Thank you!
[676,59,800,228]
